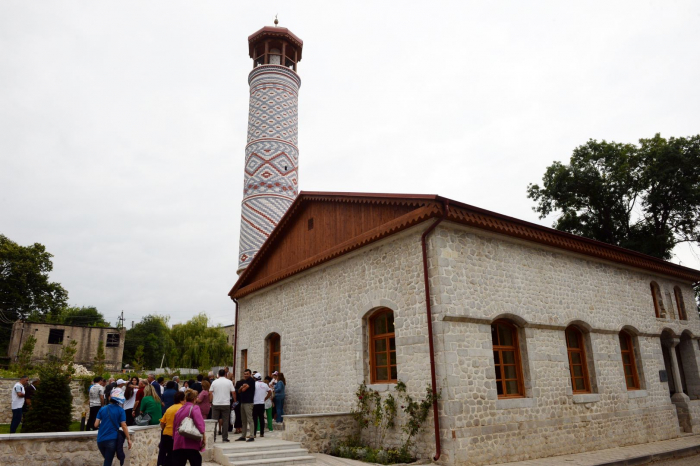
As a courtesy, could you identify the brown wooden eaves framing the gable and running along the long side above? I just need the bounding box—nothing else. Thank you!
[229,191,700,299]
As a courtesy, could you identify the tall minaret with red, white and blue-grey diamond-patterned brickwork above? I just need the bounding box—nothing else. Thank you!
[238,19,304,274]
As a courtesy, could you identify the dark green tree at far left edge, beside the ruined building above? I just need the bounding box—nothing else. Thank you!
[0,234,68,352]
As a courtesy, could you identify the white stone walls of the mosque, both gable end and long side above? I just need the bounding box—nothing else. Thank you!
[238,220,700,464]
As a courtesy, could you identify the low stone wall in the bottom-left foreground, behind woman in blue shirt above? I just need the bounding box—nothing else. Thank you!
[0,426,160,466]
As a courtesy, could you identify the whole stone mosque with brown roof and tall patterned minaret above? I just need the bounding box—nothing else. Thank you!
[229,22,700,465]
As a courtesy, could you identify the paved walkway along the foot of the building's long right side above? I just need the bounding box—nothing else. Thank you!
[499,435,700,466]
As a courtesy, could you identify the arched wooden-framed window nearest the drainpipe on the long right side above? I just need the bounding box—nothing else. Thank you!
[491,320,525,398]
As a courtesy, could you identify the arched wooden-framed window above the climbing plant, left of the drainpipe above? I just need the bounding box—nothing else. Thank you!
[369,309,397,383]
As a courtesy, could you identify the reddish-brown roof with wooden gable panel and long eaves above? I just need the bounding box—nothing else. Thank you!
[229,191,700,298]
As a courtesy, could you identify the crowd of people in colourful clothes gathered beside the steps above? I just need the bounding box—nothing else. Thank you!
[80,368,286,466]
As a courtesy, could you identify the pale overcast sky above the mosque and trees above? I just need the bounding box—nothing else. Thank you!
[0,0,700,325]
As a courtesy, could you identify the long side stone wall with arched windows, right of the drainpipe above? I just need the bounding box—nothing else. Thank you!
[430,227,700,464]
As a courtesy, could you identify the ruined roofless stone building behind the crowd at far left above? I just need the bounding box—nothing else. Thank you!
[8,321,126,371]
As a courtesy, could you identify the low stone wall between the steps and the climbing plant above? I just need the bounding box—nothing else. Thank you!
[282,413,358,453]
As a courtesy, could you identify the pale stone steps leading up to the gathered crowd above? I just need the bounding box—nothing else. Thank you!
[214,436,316,466]
